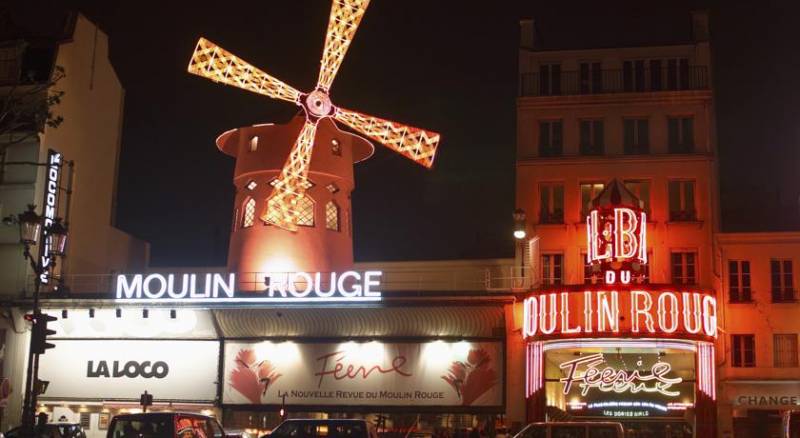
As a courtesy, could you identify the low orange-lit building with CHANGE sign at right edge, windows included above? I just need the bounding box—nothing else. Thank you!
[715,232,800,437]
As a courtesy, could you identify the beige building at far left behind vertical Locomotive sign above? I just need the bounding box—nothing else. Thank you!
[0,11,148,429]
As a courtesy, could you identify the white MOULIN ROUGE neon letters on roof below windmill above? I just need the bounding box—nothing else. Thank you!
[115,271,382,303]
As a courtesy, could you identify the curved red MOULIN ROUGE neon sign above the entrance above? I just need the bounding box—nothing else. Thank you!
[522,289,717,340]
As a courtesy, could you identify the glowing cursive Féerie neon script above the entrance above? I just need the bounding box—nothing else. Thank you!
[559,353,683,397]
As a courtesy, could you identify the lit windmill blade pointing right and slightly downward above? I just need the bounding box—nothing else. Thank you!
[334,108,441,168]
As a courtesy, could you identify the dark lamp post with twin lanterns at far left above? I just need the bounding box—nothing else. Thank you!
[16,204,68,437]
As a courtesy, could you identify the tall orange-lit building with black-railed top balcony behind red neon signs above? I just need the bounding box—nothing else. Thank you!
[517,12,719,436]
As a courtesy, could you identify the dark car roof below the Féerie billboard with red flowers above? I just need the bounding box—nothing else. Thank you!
[261,420,378,438]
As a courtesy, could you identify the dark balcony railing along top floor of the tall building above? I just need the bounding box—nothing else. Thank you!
[520,66,709,96]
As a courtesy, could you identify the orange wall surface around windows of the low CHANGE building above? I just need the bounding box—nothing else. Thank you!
[716,232,800,434]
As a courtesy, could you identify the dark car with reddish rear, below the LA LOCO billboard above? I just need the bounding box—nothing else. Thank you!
[106,412,228,438]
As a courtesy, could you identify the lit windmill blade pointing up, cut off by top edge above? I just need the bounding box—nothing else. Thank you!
[317,0,370,93]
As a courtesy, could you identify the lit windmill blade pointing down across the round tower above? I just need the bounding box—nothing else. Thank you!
[261,120,317,231]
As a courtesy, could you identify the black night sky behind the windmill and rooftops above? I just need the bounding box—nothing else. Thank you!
[9,0,800,266]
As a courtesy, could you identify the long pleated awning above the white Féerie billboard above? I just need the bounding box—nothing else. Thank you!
[214,305,505,338]
